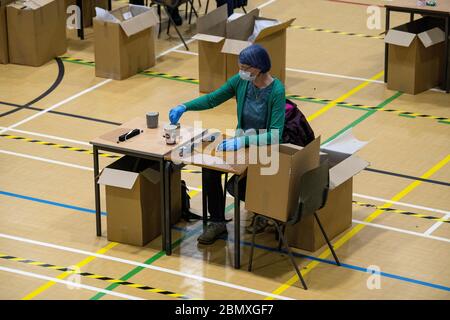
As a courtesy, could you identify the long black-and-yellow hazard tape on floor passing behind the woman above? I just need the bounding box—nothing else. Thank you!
[60,57,450,124]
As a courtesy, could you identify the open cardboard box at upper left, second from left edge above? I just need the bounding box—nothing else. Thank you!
[94,5,159,80]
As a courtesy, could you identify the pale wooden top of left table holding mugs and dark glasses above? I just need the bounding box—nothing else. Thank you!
[90,116,205,158]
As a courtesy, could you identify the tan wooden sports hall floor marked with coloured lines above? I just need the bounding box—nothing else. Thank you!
[0,0,450,299]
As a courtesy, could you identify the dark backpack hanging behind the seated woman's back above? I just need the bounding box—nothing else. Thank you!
[282,99,315,147]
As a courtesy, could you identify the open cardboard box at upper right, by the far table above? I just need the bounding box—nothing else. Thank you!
[384,17,445,94]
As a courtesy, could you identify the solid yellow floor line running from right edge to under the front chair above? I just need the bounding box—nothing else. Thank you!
[265,154,450,300]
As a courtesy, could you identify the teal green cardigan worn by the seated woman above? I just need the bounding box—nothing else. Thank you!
[184,74,286,147]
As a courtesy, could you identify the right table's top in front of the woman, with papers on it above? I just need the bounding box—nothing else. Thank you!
[164,135,250,175]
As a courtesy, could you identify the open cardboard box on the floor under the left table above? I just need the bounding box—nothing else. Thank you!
[98,156,181,246]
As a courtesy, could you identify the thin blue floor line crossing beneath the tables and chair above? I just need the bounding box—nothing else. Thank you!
[0,190,450,291]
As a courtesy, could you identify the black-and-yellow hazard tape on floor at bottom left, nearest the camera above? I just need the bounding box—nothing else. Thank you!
[0,253,191,300]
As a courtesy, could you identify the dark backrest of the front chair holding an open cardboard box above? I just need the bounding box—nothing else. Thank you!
[288,161,330,224]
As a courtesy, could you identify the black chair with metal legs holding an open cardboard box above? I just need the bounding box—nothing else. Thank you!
[248,162,341,290]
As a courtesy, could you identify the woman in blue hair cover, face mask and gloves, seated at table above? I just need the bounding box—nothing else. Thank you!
[169,44,286,244]
